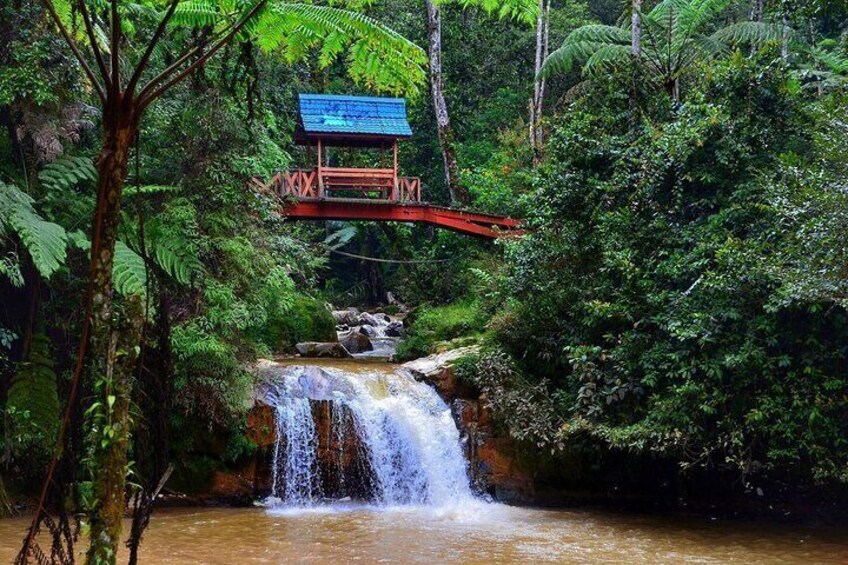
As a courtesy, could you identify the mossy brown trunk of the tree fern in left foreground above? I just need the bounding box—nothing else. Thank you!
[88,96,142,563]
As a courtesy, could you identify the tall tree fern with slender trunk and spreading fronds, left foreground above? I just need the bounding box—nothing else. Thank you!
[19,0,423,563]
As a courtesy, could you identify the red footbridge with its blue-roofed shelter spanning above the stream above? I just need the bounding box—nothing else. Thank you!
[254,94,520,238]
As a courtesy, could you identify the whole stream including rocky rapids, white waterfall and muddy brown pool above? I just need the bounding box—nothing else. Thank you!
[0,312,848,565]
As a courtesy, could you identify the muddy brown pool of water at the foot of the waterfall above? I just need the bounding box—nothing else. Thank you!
[0,503,848,565]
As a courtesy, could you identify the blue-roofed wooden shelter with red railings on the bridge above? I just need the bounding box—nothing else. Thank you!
[284,94,421,202]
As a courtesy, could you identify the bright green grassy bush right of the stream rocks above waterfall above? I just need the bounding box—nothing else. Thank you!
[396,301,488,360]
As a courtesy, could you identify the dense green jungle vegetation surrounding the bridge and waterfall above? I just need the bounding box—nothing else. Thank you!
[0,0,848,562]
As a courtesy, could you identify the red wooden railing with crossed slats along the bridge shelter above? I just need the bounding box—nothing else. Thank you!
[270,167,421,202]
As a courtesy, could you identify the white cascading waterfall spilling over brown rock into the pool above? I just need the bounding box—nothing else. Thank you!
[262,365,474,507]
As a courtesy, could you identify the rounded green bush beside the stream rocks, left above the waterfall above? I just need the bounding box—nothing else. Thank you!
[261,296,336,352]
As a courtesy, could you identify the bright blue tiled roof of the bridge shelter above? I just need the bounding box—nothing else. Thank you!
[299,94,412,137]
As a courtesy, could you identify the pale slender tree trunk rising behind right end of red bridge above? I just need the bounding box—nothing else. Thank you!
[424,0,469,204]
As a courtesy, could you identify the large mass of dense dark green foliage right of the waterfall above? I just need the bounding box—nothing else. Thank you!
[493,57,848,481]
